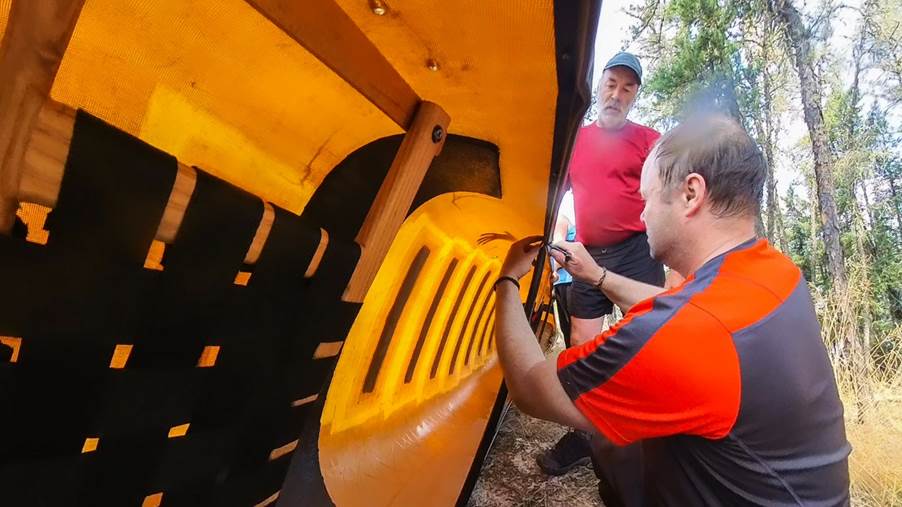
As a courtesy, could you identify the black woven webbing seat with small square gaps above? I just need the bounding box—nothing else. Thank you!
[0,112,360,505]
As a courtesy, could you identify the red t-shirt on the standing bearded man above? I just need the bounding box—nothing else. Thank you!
[570,121,661,246]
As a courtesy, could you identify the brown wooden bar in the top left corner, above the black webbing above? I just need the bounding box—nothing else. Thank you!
[0,0,84,234]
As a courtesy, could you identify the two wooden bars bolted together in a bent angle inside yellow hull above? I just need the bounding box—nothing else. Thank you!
[246,0,450,303]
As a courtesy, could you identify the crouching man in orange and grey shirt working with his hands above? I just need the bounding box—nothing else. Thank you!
[495,116,850,505]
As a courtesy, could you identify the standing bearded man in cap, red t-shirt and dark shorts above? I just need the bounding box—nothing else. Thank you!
[537,52,664,500]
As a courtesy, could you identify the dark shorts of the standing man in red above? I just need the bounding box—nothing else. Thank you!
[568,232,664,319]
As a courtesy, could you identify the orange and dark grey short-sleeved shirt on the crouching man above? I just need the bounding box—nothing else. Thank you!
[557,240,851,505]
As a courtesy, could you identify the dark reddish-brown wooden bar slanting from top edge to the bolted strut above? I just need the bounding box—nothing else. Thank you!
[247,0,420,130]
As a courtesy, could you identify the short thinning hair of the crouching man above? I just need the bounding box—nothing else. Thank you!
[655,114,767,218]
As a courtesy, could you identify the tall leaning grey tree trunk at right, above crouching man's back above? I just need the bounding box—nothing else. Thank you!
[775,0,848,292]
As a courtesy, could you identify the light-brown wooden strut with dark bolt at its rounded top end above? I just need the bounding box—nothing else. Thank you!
[342,102,451,303]
